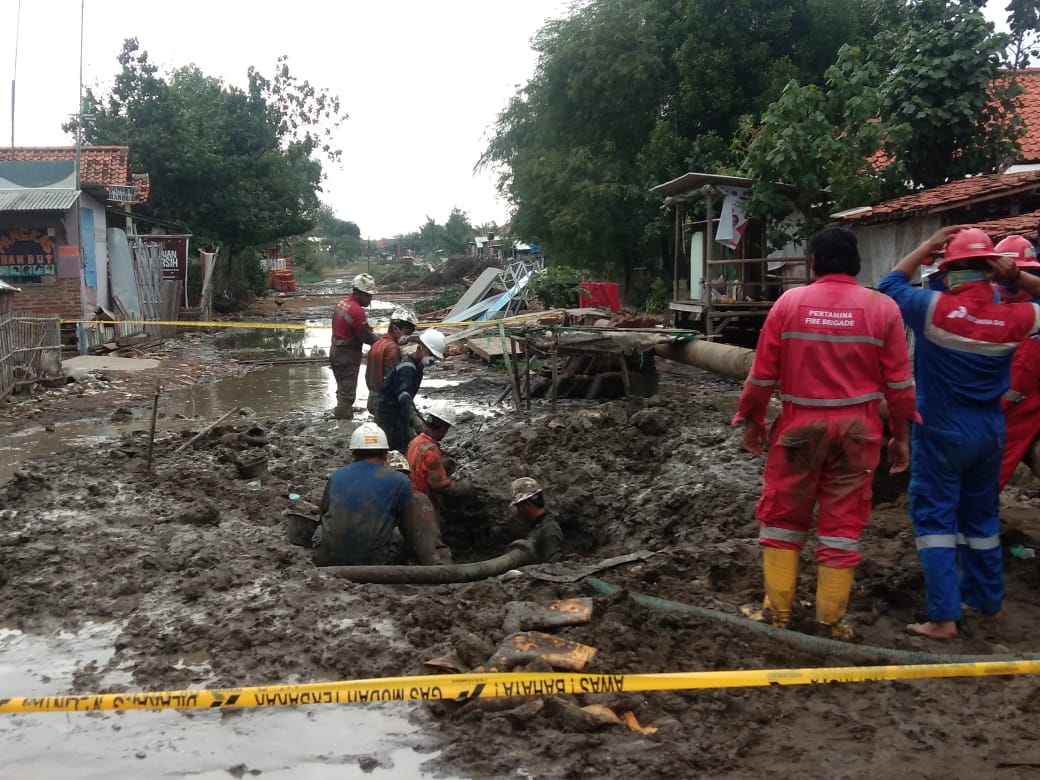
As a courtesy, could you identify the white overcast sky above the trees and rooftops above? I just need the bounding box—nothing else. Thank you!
[0,0,1006,238]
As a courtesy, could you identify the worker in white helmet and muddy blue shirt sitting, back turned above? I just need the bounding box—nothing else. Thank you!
[312,422,412,566]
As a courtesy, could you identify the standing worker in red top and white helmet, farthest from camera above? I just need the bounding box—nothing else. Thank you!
[329,274,375,420]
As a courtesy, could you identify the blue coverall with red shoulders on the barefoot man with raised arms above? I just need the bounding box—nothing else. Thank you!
[878,270,1040,622]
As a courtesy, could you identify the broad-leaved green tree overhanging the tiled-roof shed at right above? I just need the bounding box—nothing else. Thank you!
[734,0,1022,242]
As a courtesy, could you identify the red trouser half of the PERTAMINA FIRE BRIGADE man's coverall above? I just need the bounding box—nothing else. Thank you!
[755,407,881,569]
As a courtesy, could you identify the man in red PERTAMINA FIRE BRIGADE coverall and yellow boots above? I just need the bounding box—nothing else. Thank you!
[733,228,916,639]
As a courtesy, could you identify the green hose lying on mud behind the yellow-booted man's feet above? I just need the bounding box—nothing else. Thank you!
[586,577,1040,664]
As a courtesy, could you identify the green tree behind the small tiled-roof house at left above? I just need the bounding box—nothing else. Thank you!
[78,38,346,304]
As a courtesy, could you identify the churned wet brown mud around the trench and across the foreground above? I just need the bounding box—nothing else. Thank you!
[0,324,1040,778]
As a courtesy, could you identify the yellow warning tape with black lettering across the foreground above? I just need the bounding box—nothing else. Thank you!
[0,660,1040,712]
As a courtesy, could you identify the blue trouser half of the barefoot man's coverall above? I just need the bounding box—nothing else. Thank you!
[910,422,1004,622]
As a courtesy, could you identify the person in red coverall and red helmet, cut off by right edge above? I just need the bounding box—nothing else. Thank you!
[995,236,1040,490]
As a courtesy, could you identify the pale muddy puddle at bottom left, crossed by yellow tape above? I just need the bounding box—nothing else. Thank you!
[0,624,447,780]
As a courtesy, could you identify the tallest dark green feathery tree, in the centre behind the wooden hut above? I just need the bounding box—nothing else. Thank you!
[478,0,876,289]
